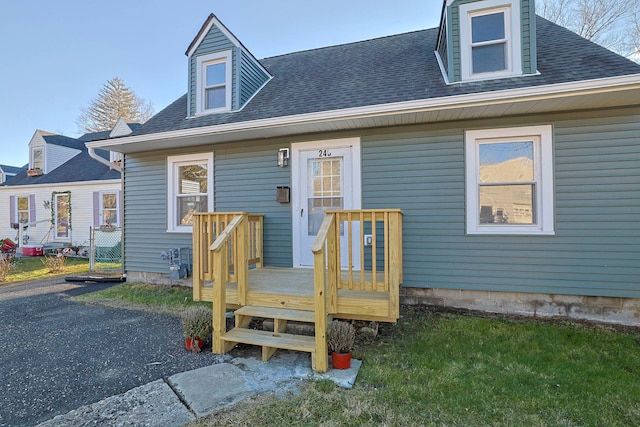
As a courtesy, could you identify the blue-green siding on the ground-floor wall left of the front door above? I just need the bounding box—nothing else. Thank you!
[124,142,292,273]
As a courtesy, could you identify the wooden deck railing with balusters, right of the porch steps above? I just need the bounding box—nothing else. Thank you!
[313,209,402,318]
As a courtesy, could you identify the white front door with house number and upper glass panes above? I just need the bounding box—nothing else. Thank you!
[291,138,361,267]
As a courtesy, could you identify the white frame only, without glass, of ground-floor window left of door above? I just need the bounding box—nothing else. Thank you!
[167,153,214,233]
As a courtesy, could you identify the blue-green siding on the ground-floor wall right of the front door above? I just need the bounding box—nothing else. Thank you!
[362,109,640,298]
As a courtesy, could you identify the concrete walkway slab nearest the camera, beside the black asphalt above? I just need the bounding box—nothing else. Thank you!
[38,380,196,427]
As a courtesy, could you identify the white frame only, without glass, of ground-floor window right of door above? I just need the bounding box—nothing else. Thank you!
[465,125,555,235]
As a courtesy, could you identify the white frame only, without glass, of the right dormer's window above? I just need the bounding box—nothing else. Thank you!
[460,0,522,81]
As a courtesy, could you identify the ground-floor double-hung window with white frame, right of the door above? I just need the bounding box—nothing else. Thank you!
[465,126,554,234]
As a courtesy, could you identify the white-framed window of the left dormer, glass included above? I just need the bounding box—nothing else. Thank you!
[196,51,232,114]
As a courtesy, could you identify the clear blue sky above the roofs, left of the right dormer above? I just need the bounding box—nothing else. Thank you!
[0,0,442,166]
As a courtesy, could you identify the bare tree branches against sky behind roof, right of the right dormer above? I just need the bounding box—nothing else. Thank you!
[537,0,640,61]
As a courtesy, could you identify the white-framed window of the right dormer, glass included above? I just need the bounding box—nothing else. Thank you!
[460,0,522,80]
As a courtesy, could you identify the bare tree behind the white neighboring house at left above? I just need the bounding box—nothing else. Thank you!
[76,77,154,133]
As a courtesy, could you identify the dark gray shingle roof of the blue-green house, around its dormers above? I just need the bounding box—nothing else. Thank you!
[132,17,640,135]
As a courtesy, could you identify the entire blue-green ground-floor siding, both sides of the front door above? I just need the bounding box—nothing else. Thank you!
[125,108,640,298]
